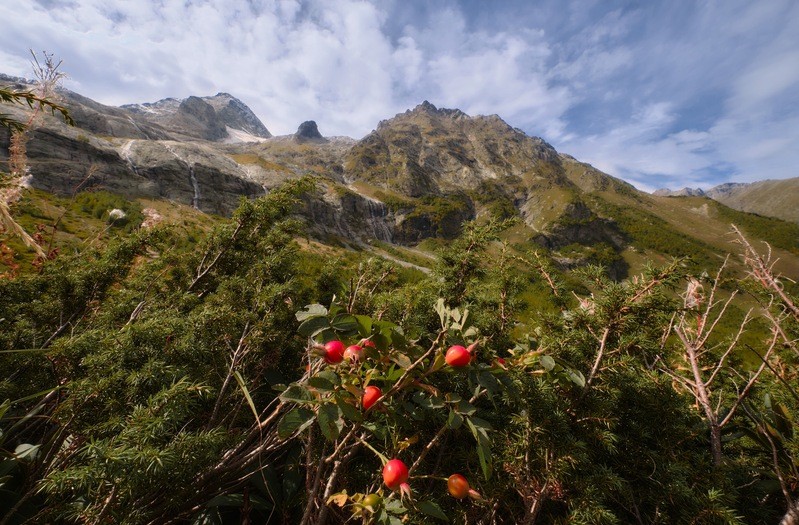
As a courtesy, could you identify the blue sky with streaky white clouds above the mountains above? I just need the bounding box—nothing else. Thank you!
[0,0,799,191]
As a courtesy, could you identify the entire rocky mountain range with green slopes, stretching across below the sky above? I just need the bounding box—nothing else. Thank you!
[0,71,799,278]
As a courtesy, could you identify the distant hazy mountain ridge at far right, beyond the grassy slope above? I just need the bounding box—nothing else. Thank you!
[653,177,799,223]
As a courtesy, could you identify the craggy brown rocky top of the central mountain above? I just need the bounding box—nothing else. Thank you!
[345,101,560,197]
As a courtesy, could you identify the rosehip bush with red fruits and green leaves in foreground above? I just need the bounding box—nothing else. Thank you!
[278,300,580,524]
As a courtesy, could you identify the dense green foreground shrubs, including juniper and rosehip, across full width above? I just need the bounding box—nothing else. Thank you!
[0,180,799,524]
